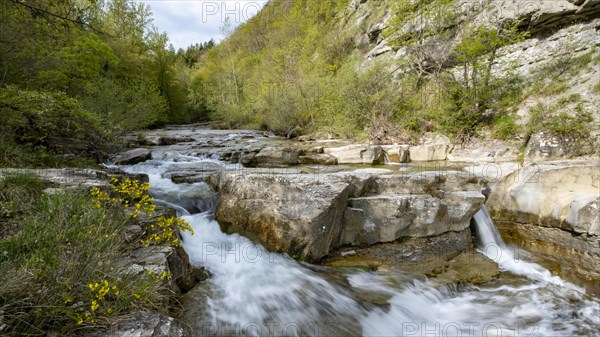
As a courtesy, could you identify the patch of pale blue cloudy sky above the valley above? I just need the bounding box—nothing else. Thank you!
[141,0,267,50]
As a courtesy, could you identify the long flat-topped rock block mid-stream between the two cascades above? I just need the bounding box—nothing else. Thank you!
[216,171,486,261]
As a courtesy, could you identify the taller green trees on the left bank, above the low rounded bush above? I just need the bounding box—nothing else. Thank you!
[0,0,204,138]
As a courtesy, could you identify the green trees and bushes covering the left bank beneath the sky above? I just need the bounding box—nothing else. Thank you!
[0,0,214,166]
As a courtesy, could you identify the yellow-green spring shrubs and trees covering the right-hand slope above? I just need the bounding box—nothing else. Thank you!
[190,0,527,142]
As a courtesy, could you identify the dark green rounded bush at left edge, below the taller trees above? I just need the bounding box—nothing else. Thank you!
[0,86,112,166]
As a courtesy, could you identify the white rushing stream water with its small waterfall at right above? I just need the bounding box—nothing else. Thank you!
[119,153,600,337]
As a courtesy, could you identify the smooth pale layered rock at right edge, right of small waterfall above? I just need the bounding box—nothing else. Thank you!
[487,163,600,294]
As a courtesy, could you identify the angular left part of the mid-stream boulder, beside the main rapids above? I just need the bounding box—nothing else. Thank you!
[215,173,349,261]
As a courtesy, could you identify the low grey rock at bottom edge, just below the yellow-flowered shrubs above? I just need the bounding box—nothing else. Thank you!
[87,312,185,337]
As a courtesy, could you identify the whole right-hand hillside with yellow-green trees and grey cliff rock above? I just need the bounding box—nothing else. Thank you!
[192,0,600,152]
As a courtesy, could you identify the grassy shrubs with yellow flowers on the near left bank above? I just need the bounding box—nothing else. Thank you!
[0,174,189,336]
